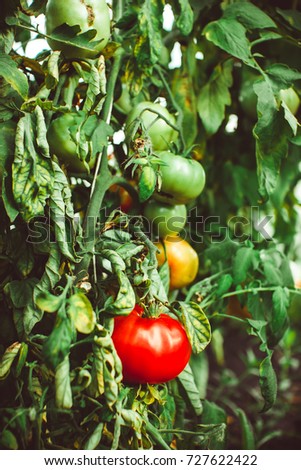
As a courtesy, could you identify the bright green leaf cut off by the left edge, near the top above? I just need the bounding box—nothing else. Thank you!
[0,53,28,99]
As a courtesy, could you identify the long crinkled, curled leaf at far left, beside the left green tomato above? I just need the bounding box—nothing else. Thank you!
[12,106,54,222]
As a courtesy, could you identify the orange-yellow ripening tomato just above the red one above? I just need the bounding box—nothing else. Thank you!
[155,236,199,290]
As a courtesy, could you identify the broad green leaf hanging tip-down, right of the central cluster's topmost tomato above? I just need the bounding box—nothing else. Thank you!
[197,60,233,134]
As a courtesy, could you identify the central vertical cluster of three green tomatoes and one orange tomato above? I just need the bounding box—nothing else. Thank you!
[125,102,206,290]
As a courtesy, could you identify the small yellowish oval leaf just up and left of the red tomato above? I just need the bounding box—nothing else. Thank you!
[68,293,96,335]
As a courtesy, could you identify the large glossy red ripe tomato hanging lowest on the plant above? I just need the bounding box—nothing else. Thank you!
[112,306,191,384]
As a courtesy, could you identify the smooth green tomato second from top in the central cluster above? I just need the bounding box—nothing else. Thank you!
[154,152,206,204]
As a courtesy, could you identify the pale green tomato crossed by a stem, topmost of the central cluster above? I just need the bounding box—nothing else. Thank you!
[125,101,178,150]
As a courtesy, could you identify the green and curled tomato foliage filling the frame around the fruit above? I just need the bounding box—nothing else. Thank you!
[0,0,301,450]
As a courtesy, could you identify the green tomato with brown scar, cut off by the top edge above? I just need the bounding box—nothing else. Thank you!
[46,0,110,59]
